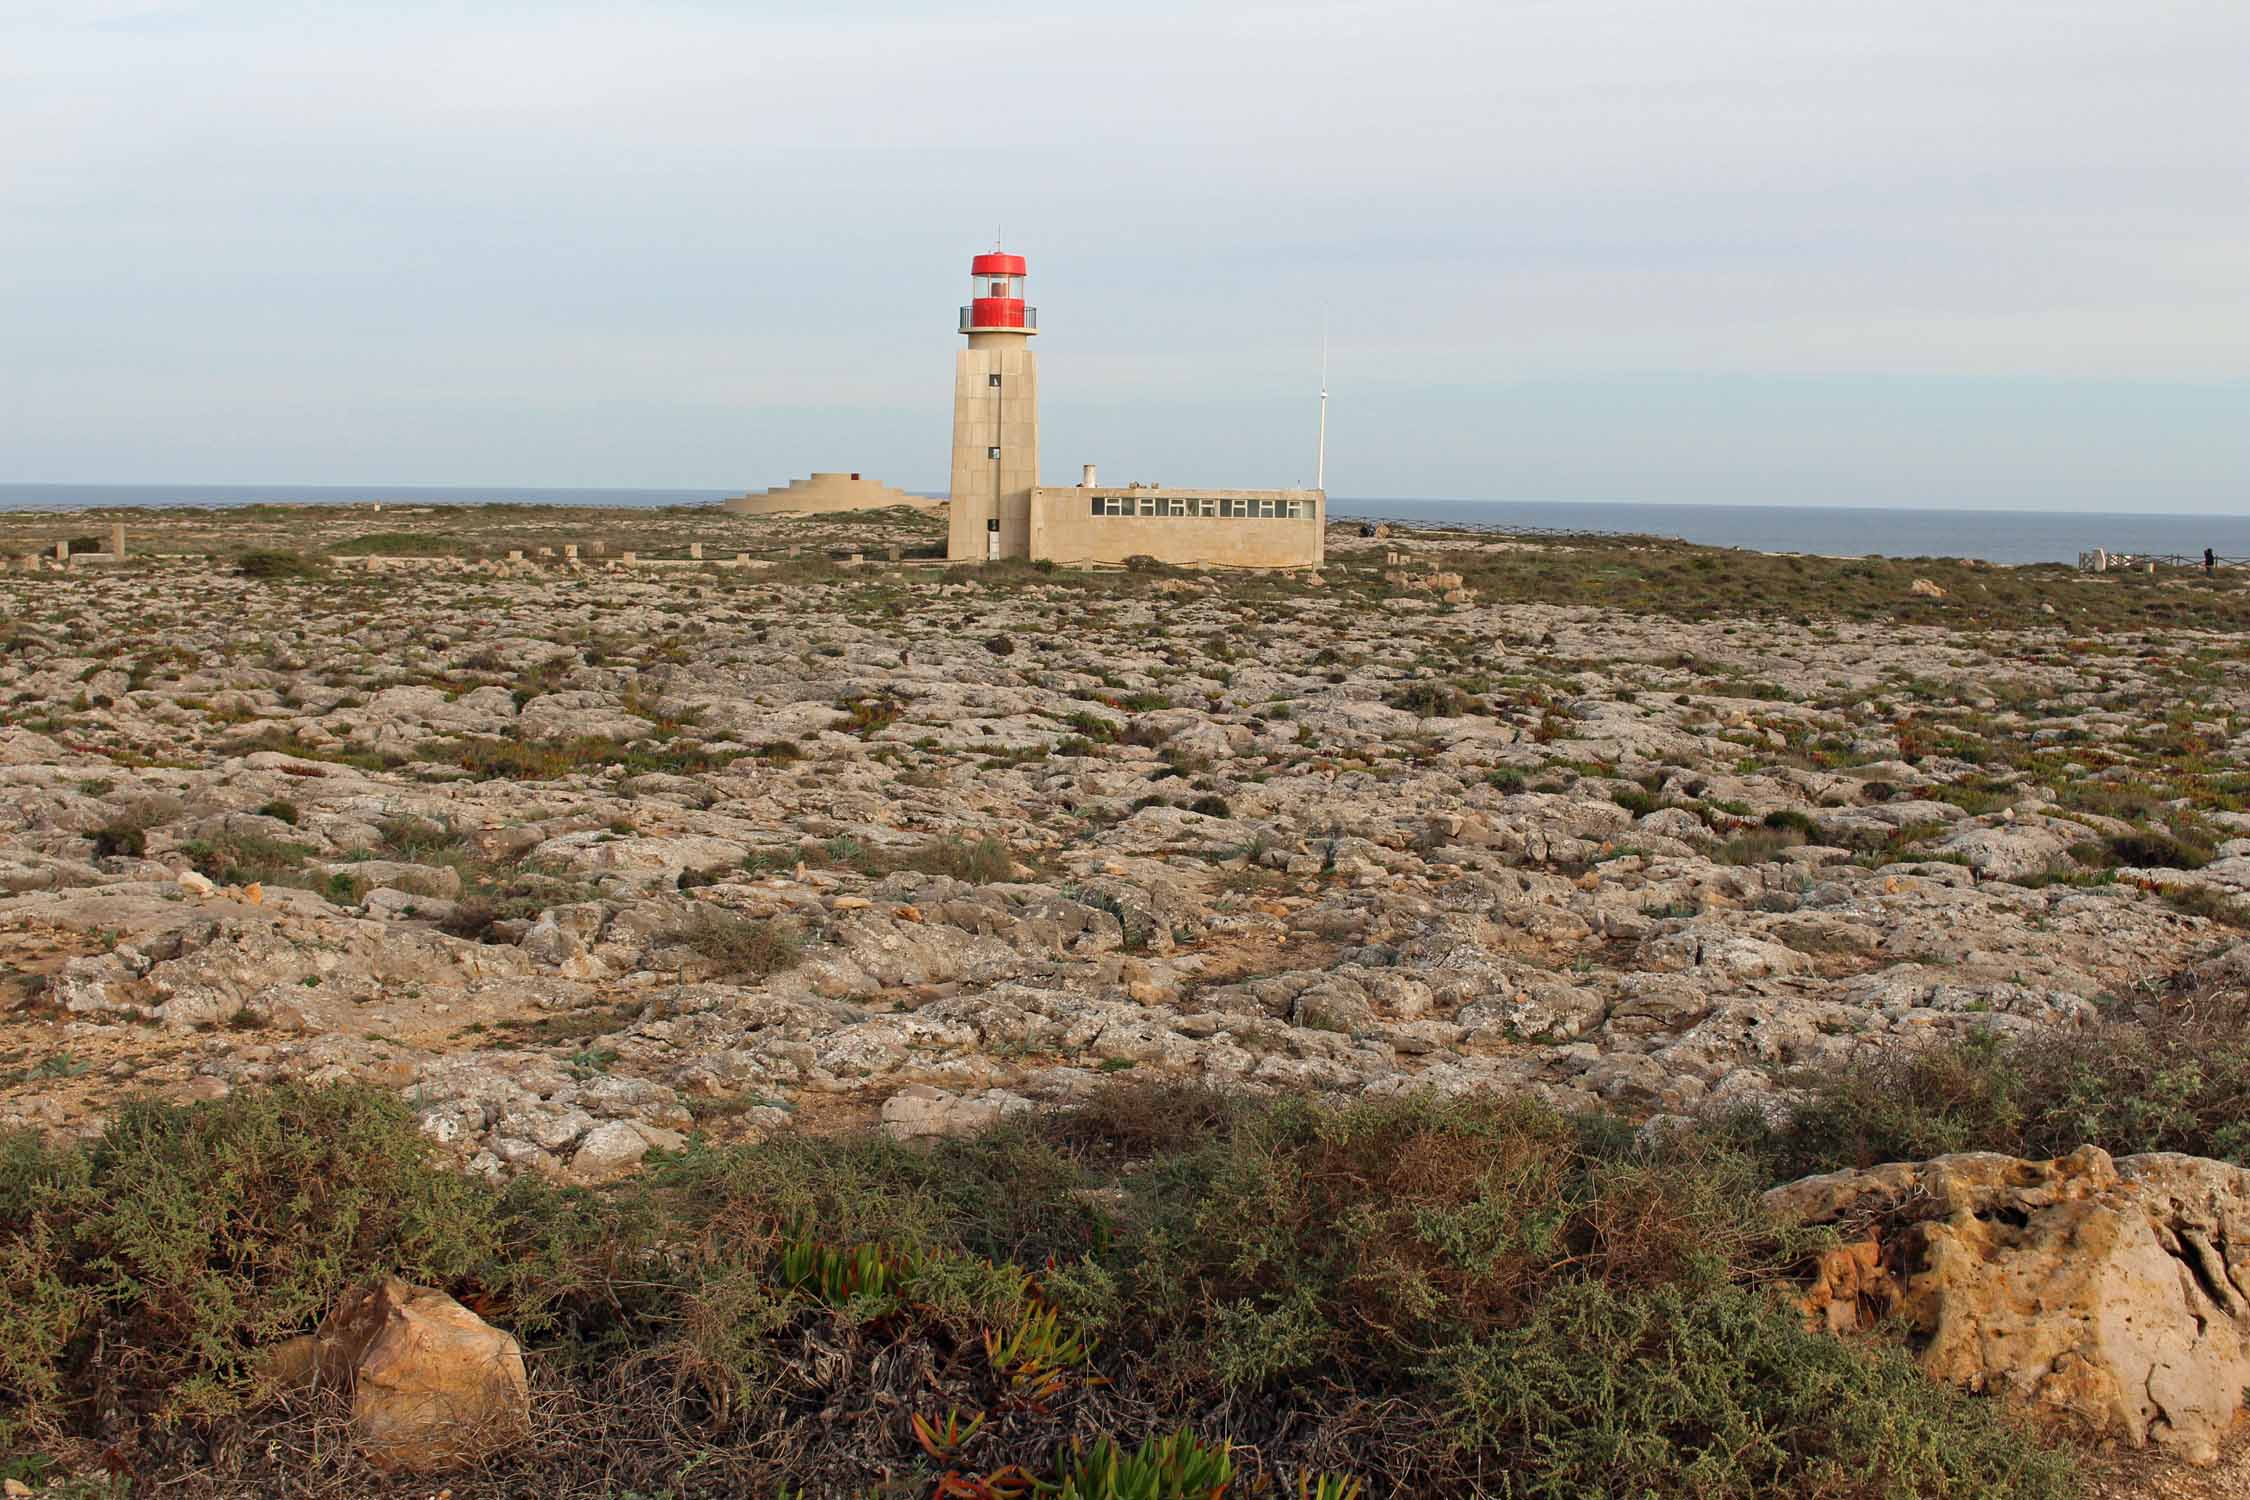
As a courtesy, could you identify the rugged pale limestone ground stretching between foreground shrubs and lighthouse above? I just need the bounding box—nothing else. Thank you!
[0,510,2250,1181]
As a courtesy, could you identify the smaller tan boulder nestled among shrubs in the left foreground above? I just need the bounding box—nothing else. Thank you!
[270,1277,531,1473]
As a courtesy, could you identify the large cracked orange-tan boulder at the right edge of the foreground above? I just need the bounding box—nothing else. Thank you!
[1766,1147,2250,1464]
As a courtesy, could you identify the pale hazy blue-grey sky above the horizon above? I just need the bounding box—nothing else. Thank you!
[0,0,2250,513]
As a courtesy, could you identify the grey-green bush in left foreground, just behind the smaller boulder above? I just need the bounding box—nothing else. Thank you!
[0,1086,504,1424]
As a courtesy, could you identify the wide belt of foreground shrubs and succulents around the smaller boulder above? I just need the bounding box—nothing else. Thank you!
[0,1084,2070,1500]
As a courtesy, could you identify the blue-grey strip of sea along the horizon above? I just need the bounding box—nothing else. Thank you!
[0,484,2250,562]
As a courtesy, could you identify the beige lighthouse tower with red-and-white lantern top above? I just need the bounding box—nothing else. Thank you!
[945,252,1040,562]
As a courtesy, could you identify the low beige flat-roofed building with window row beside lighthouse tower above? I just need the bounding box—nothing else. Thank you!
[1031,486,1328,569]
